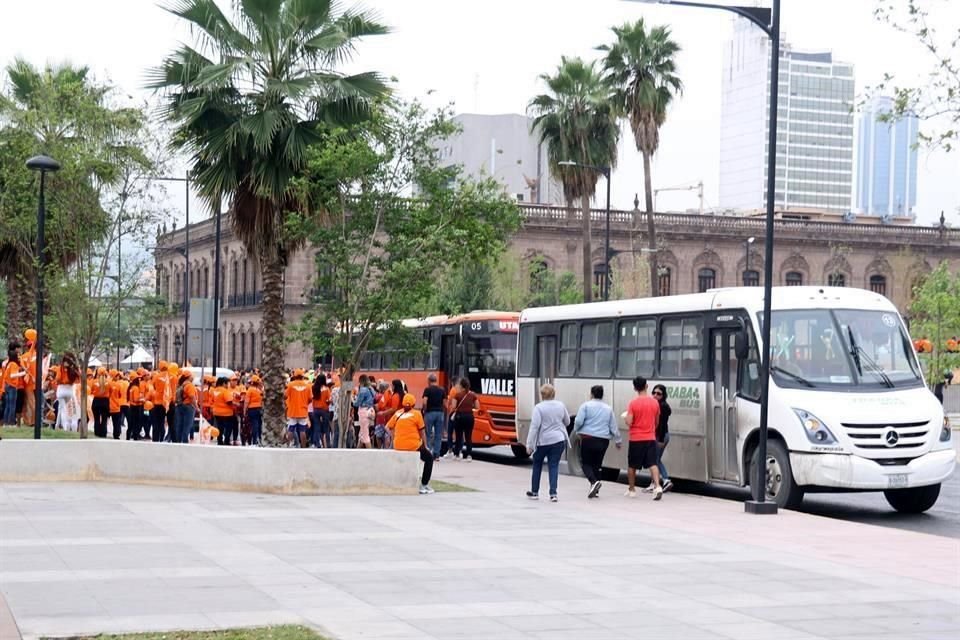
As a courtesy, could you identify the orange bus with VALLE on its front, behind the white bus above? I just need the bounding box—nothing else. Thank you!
[359,311,527,457]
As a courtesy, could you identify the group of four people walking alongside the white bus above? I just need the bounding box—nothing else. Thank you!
[526,376,673,502]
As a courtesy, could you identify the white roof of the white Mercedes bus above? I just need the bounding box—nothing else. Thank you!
[520,287,896,323]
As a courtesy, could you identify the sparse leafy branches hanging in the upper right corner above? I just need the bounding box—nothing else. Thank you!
[868,0,960,151]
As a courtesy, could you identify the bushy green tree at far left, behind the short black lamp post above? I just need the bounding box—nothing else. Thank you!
[0,59,141,337]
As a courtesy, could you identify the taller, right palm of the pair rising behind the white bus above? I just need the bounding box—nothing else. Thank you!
[599,18,683,296]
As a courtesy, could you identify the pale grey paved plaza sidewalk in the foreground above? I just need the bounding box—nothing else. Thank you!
[0,461,960,640]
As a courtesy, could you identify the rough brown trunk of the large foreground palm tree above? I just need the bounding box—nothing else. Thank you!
[260,248,287,447]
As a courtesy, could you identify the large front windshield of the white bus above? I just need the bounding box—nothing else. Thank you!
[770,309,922,389]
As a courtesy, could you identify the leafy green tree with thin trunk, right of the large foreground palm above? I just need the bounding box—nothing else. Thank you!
[290,102,520,444]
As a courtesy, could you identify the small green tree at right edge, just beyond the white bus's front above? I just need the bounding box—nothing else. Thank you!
[910,261,960,384]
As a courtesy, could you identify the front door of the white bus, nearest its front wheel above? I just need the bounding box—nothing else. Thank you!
[707,327,740,481]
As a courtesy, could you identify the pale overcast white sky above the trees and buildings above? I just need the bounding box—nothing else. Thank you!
[0,0,960,226]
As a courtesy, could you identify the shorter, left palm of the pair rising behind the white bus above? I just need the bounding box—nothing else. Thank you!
[528,57,620,302]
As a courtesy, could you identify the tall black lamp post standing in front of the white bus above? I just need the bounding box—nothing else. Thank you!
[627,0,780,514]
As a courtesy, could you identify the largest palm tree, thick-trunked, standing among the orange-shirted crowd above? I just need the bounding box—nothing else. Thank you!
[150,0,389,444]
